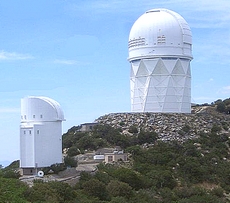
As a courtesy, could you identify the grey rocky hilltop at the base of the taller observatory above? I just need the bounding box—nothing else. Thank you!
[96,106,230,142]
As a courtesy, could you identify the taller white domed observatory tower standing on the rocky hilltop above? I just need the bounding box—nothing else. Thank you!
[128,9,192,113]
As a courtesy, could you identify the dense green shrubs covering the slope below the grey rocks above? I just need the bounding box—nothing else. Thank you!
[0,100,230,203]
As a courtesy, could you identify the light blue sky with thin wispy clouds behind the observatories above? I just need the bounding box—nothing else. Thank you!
[0,0,230,164]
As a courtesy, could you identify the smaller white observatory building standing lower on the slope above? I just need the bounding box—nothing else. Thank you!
[20,96,64,175]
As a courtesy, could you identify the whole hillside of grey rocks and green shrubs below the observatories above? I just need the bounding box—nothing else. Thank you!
[0,105,230,203]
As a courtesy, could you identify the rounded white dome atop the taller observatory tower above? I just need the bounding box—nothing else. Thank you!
[129,9,192,61]
